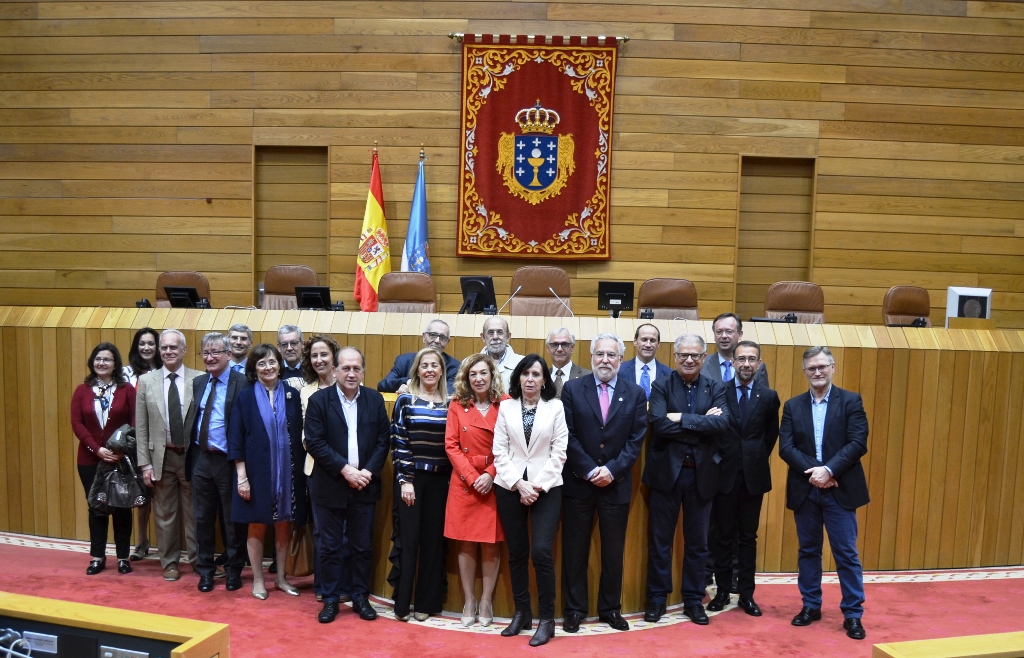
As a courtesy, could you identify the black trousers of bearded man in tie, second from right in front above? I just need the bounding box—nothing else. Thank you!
[715,472,764,599]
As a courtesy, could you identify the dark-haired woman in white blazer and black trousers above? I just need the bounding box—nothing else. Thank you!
[494,354,568,647]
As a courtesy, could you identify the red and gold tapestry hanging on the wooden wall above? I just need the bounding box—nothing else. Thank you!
[458,35,617,260]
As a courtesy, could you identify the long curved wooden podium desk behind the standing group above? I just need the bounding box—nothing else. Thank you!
[0,307,1024,615]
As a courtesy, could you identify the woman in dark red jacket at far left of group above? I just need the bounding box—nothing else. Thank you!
[71,343,135,576]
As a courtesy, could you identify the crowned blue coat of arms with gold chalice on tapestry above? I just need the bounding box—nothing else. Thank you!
[497,100,575,206]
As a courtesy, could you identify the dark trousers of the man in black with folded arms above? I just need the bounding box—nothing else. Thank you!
[647,469,712,606]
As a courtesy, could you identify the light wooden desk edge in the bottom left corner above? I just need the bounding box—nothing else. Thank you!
[0,591,229,658]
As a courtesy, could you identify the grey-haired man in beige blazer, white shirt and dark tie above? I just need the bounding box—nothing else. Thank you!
[135,330,202,581]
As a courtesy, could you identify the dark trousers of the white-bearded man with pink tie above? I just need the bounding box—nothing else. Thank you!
[562,494,630,616]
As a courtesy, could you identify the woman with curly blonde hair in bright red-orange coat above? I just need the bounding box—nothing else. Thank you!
[444,353,508,626]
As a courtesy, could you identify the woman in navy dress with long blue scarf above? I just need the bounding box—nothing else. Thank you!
[227,343,306,600]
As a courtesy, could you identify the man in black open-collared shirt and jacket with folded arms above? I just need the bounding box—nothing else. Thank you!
[643,334,729,625]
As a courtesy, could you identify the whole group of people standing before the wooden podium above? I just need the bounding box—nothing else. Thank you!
[72,313,867,646]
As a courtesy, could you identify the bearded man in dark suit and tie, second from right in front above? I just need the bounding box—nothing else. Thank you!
[708,341,779,617]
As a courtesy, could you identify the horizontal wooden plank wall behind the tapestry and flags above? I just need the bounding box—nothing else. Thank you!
[0,0,1024,327]
